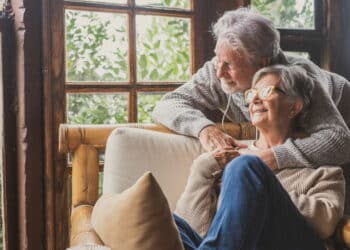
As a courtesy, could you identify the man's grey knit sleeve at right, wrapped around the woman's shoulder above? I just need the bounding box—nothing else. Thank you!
[272,62,350,169]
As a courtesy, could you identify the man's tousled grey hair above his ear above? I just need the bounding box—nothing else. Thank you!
[212,8,280,65]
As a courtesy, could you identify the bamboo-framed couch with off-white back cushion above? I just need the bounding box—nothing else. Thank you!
[59,123,350,250]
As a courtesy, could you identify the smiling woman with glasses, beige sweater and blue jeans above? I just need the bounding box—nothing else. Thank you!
[174,66,345,250]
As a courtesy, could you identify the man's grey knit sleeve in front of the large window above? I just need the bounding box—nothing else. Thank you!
[152,61,228,137]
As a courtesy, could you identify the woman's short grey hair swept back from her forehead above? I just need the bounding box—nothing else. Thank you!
[252,65,315,120]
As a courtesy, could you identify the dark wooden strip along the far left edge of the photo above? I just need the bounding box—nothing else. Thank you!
[0,5,19,249]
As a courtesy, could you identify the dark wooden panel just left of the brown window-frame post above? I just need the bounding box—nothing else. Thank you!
[11,0,45,250]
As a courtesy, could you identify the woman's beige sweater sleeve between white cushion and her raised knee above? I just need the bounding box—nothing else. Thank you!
[175,153,221,236]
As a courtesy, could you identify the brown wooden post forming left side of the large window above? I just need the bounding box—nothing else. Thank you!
[42,0,70,250]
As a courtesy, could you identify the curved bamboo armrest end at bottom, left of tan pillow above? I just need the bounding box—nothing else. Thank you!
[70,205,103,246]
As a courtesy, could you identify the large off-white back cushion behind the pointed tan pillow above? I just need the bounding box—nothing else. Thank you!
[103,128,204,211]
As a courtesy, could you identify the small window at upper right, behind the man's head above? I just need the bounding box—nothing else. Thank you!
[251,0,324,64]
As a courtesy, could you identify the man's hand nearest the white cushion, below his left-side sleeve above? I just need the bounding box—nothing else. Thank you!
[199,125,247,151]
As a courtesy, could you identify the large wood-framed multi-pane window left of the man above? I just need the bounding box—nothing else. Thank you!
[64,0,194,124]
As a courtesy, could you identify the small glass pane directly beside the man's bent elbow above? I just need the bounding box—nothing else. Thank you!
[137,92,165,123]
